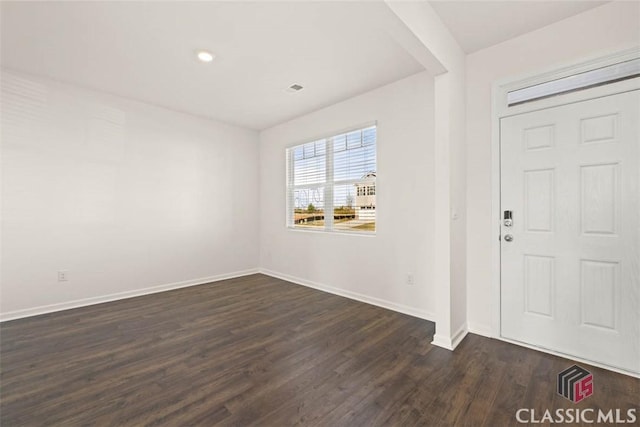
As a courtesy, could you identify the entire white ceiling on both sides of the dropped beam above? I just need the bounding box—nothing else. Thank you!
[0,0,604,129]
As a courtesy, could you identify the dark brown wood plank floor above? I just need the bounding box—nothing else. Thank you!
[0,275,640,427]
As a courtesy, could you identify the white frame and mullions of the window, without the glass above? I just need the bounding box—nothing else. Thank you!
[285,121,379,237]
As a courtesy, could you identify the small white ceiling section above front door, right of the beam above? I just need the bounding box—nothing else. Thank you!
[430,0,608,53]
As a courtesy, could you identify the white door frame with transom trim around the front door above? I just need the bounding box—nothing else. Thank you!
[490,45,640,378]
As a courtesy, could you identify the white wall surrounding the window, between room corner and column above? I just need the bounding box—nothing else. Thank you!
[260,72,435,318]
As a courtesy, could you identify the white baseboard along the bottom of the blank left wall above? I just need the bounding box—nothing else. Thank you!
[0,268,259,322]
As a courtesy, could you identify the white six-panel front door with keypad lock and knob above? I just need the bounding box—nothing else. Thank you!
[500,90,640,373]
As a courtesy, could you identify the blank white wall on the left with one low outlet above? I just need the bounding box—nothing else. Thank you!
[0,71,259,318]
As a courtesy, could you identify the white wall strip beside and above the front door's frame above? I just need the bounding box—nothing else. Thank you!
[466,2,640,335]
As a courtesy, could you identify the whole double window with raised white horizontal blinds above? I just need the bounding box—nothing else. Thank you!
[286,125,377,233]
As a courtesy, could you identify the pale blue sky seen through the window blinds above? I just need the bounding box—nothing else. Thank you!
[293,126,376,209]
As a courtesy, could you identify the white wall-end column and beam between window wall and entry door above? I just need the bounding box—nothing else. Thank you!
[386,0,467,350]
